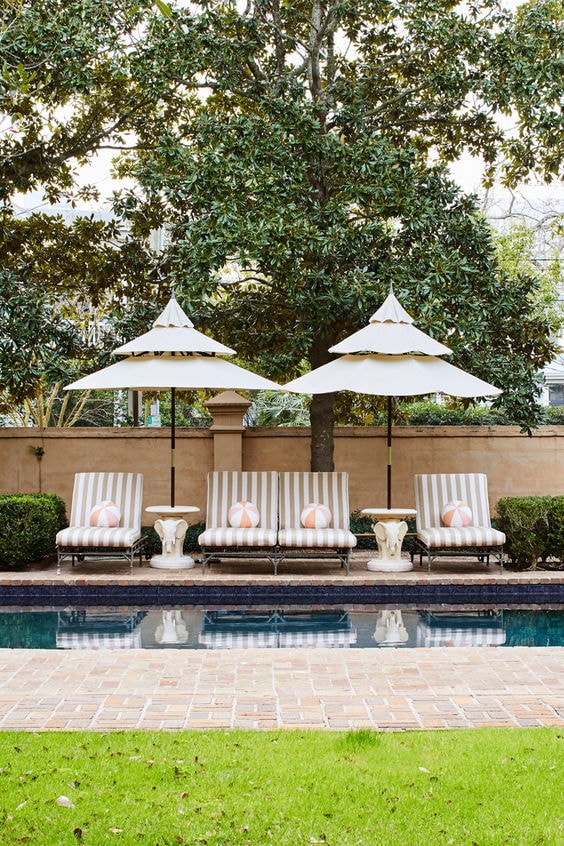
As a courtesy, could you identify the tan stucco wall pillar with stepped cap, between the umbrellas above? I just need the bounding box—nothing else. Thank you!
[204,391,251,470]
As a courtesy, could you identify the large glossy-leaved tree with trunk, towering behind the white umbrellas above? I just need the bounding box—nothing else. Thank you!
[0,0,564,467]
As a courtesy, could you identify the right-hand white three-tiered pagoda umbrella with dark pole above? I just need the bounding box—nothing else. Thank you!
[283,287,501,509]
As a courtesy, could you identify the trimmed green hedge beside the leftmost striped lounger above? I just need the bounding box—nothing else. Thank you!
[0,494,68,569]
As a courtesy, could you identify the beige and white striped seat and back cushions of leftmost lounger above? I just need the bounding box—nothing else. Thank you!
[56,473,143,547]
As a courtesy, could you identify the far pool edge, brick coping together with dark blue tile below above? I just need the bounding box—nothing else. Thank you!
[0,550,564,608]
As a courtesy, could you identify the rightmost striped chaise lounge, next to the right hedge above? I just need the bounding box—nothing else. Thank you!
[414,473,505,572]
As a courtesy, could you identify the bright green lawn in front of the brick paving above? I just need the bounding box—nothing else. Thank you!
[0,728,564,846]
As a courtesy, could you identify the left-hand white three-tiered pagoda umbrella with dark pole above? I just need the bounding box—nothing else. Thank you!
[65,295,281,506]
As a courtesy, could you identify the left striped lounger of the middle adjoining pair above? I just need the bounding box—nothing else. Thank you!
[198,470,278,573]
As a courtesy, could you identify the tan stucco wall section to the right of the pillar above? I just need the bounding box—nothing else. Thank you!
[243,426,564,510]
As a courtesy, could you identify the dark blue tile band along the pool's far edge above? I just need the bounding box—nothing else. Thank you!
[0,582,564,607]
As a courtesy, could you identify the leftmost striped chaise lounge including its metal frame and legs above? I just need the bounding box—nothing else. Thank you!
[56,473,146,574]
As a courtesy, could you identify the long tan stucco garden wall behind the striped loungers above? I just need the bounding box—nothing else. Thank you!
[0,425,564,525]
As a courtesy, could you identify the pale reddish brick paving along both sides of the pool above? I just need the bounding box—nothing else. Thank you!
[0,552,564,731]
